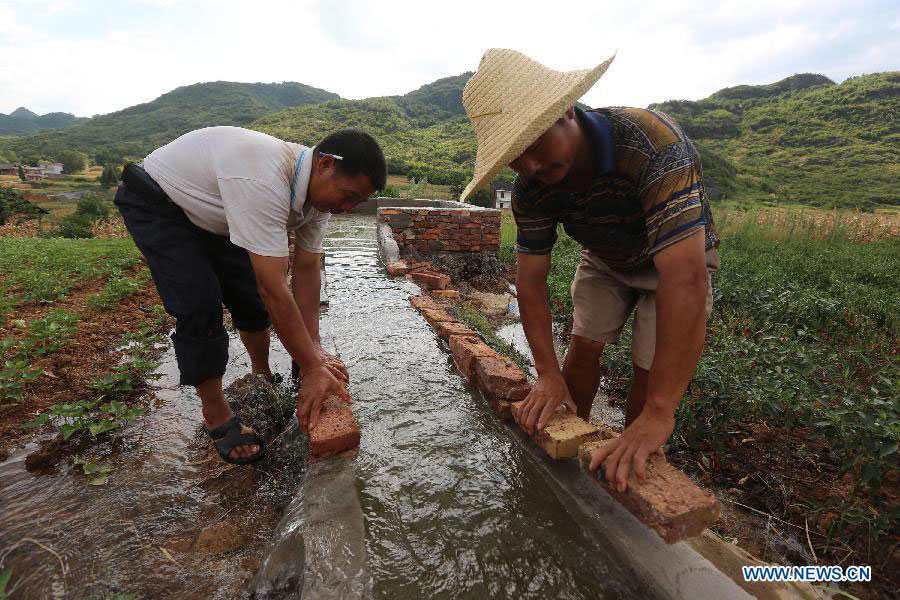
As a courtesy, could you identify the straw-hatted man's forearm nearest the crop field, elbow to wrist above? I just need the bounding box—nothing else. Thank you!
[646,280,708,416]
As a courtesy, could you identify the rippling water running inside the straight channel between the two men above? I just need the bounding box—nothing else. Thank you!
[322,215,639,599]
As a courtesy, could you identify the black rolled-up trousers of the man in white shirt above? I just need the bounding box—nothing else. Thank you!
[114,176,271,385]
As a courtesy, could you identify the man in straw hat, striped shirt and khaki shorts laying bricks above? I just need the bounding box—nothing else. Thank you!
[462,48,719,491]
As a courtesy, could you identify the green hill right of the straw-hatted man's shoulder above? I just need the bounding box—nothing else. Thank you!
[651,72,900,209]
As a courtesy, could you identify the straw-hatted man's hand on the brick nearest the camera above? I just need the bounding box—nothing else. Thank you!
[591,406,675,493]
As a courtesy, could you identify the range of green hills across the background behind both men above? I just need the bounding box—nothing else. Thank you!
[0,72,900,209]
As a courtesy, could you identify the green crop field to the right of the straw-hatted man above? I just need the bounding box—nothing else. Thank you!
[501,209,900,576]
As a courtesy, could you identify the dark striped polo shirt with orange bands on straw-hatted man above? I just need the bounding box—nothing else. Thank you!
[512,107,719,271]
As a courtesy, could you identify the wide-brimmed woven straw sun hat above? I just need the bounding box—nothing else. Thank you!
[460,48,615,200]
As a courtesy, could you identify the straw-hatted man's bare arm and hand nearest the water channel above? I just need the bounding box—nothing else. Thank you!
[516,252,575,432]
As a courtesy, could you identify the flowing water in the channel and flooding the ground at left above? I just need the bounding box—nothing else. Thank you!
[0,215,643,600]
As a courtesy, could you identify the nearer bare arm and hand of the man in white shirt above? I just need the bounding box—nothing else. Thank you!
[249,252,350,431]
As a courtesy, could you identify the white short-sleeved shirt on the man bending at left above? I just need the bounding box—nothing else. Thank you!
[144,127,331,256]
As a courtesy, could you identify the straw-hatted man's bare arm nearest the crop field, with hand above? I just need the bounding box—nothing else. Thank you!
[591,229,709,492]
